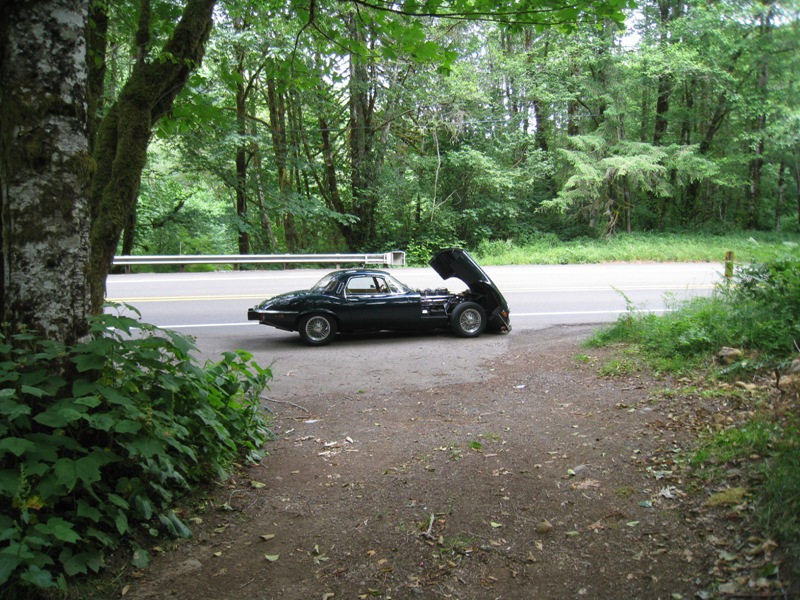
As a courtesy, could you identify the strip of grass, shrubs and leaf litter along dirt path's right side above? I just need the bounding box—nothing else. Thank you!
[589,245,800,591]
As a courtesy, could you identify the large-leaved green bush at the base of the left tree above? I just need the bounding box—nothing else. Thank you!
[0,315,271,598]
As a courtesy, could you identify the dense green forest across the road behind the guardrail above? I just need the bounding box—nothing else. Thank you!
[109,0,800,258]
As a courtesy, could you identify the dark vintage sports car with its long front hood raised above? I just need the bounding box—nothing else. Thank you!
[247,248,511,346]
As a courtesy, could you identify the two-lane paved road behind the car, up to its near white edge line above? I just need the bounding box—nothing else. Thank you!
[103,263,722,335]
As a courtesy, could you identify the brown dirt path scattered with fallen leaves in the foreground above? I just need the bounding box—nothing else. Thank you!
[113,326,790,600]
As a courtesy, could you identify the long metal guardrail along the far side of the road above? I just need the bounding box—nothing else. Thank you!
[114,250,406,267]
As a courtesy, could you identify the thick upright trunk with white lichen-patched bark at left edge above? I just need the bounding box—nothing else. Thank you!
[0,0,93,343]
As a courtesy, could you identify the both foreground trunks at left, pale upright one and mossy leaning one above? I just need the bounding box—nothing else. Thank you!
[0,0,216,344]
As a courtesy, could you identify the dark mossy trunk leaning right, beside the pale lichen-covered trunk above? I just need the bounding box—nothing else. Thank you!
[88,0,216,312]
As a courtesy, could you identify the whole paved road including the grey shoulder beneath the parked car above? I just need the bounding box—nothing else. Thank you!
[107,263,723,393]
